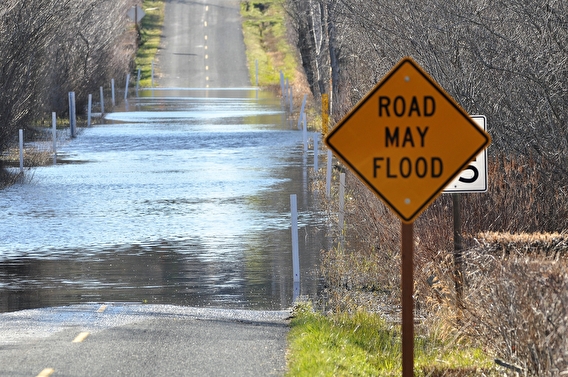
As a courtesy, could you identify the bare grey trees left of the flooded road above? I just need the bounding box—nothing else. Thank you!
[0,0,136,168]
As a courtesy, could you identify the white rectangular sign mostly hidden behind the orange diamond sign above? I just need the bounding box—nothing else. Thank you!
[444,115,487,193]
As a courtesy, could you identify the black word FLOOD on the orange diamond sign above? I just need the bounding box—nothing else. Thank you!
[373,157,444,178]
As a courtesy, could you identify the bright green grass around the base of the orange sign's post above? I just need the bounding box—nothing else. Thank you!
[287,306,493,377]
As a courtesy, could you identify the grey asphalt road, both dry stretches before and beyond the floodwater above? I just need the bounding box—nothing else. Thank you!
[0,0,290,377]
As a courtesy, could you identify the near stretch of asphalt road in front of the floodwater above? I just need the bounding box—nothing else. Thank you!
[0,303,289,377]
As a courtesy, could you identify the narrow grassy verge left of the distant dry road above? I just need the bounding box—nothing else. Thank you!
[136,0,166,87]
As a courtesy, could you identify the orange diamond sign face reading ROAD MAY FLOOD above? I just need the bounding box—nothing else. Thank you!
[325,58,491,223]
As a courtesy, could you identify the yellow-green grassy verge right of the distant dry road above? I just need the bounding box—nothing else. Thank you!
[241,0,298,86]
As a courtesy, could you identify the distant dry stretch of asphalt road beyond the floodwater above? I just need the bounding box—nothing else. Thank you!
[156,0,250,88]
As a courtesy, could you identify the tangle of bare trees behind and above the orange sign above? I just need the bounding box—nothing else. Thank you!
[288,0,568,231]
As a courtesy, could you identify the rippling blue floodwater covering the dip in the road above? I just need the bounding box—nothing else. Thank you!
[0,89,325,312]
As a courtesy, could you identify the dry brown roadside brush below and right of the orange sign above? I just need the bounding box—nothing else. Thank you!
[313,166,568,376]
